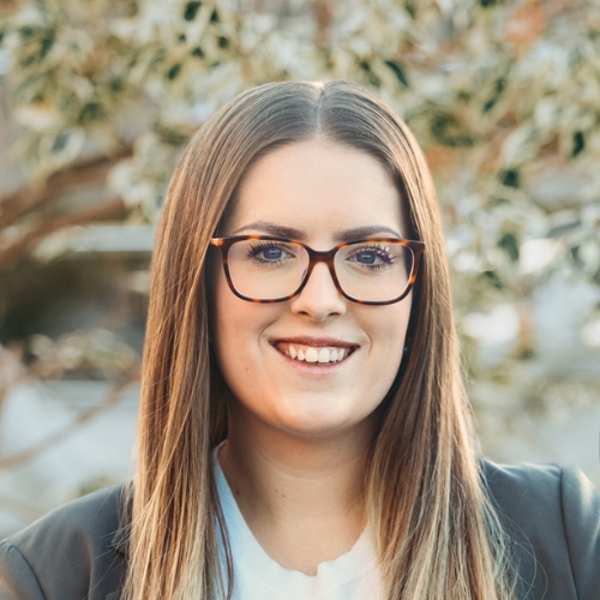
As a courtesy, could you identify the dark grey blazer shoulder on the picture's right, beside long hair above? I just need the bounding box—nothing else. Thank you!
[481,461,600,599]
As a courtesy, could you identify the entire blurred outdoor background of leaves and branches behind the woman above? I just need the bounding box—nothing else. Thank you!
[0,0,600,536]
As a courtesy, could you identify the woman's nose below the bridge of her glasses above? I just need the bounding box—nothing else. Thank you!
[290,262,347,323]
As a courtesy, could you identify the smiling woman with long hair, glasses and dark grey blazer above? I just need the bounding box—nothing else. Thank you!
[0,81,600,600]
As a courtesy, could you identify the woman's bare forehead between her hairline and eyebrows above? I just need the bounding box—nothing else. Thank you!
[225,140,405,240]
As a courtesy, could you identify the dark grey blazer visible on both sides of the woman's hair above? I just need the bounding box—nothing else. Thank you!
[0,461,600,600]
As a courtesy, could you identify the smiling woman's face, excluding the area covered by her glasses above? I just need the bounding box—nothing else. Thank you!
[212,140,412,437]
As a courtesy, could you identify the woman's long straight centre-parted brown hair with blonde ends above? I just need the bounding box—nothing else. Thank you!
[125,80,514,600]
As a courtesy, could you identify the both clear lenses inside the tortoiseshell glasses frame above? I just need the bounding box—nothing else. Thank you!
[228,239,414,302]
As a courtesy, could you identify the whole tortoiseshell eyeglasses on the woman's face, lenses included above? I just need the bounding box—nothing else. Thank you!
[210,235,425,304]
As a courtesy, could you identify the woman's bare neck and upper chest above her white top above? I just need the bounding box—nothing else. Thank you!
[219,404,371,574]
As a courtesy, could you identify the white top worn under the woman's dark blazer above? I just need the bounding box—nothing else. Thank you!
[214,452,384,600]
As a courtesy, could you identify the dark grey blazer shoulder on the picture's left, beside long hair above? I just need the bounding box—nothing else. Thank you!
[0,486,125,600]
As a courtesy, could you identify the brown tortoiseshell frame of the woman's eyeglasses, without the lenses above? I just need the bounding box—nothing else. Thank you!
[210,235,425,306]
